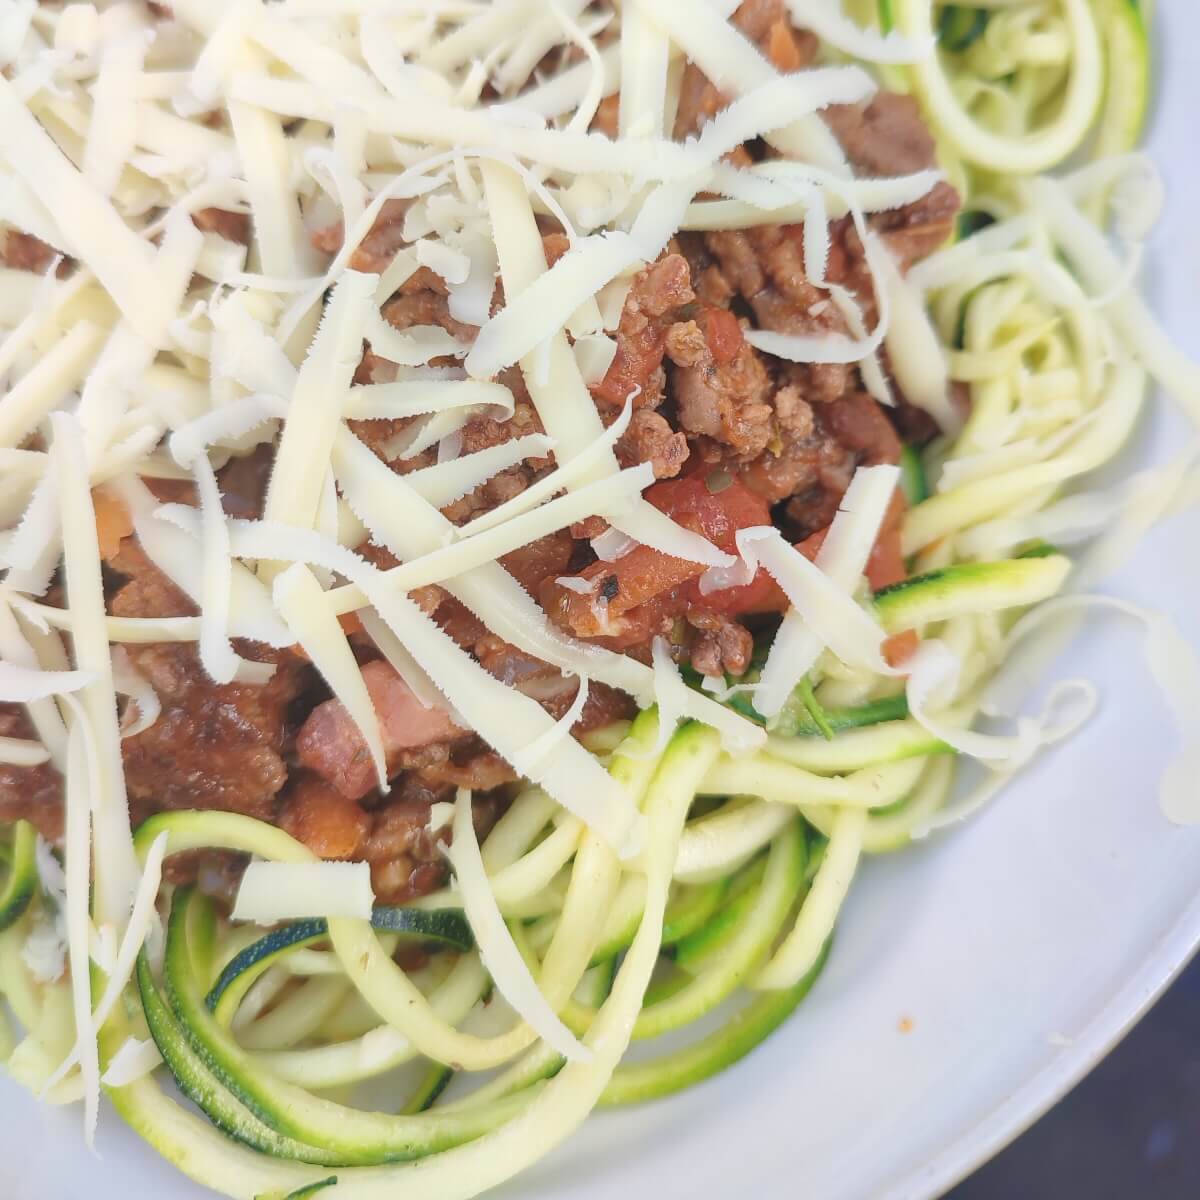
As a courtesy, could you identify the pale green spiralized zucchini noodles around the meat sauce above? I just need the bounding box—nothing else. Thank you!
[0,0,1200,1200]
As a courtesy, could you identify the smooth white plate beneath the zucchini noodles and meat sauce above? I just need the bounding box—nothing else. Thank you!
[0,9,1200,1200]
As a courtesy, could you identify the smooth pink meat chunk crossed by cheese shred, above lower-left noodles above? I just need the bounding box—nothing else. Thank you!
[296,661,464,800]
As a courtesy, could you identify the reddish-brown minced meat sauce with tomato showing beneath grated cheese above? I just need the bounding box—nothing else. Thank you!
[0,0,959,902]
